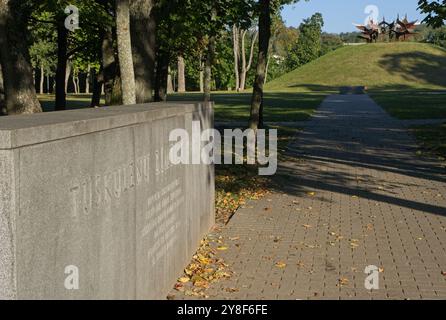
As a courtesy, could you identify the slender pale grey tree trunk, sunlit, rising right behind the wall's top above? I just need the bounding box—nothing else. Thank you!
[116,0,136,105]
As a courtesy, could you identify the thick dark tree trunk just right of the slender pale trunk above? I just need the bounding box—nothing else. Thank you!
[130,0,156,103]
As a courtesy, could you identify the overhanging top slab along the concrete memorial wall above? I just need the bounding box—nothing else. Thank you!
[0,102,199,150]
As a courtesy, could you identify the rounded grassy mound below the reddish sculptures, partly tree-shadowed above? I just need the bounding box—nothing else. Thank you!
[266,42,446,92]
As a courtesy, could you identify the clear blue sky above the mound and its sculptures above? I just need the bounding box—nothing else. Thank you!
[282,0,424,33]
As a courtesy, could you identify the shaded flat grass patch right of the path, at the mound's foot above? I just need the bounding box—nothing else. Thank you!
[370,89,446,120]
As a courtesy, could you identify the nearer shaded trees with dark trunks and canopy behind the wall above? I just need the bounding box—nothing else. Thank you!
[0,0,295,127]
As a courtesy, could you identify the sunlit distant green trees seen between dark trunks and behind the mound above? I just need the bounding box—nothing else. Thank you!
[24,14,446,94]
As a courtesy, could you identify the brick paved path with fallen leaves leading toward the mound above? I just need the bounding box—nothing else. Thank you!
[186,95,446,299]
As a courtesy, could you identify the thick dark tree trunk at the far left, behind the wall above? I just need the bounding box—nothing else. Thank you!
[0,0,42,114]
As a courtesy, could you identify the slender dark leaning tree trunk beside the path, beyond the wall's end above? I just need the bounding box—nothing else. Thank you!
[249,0,271,130]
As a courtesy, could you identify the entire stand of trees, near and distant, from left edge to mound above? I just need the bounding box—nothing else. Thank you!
[0,0,445,128]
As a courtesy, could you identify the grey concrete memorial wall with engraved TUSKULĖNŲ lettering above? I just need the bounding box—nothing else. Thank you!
[0,103,214,299]
